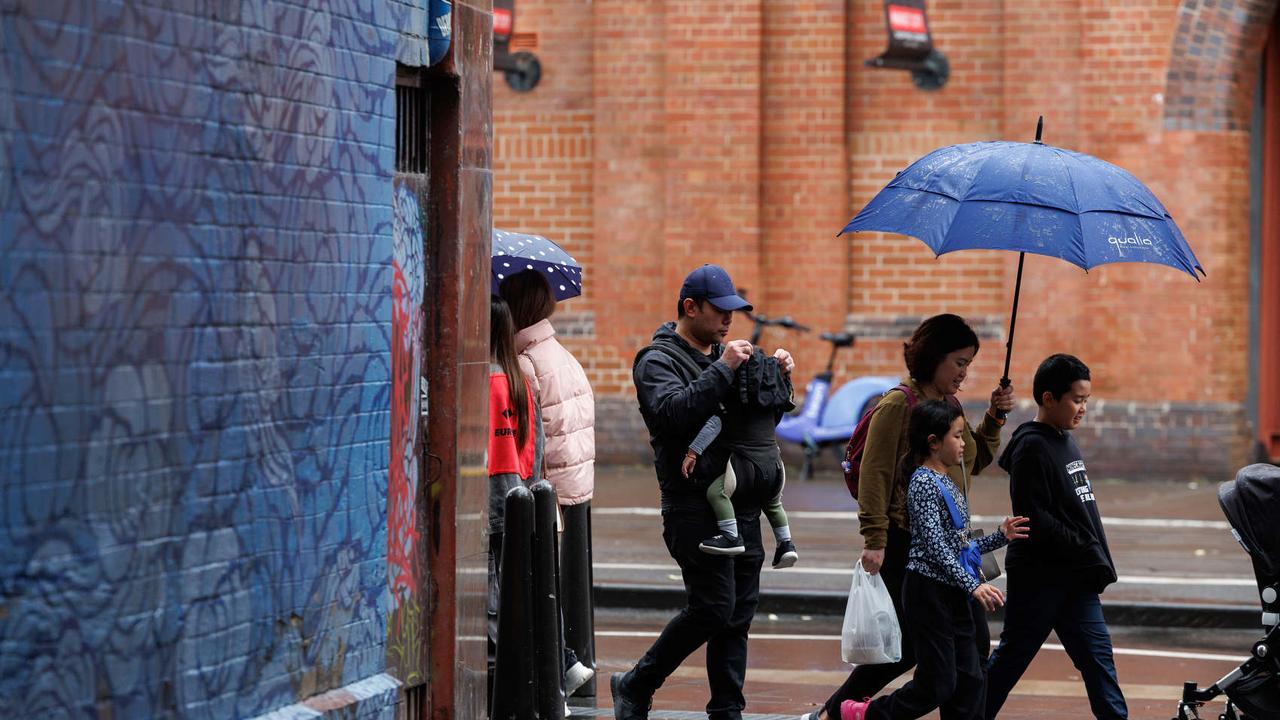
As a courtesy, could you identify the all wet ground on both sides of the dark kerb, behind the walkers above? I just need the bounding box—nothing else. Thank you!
[579,466,1261,720]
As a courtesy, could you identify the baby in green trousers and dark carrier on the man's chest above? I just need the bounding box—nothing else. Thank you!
[680,350,800,570]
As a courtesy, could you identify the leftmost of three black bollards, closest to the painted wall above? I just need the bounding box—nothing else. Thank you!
[489,484,536,720]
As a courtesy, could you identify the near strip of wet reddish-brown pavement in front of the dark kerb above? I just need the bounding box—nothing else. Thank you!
[576,611,1260,720]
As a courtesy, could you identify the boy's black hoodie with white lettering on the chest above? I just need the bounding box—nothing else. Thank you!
[1000,420,1116,593]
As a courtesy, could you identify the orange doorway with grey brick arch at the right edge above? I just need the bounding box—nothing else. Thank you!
[1165,0,1280,460]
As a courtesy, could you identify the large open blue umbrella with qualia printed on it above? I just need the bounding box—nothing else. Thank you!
[841,118,1204,397]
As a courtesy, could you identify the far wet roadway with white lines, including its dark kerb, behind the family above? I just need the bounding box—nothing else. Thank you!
[593,466,1261,628]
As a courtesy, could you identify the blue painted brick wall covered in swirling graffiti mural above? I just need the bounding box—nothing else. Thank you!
[0,0,428,719]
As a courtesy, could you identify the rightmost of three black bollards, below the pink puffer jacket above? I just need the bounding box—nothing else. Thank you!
[561,501,595,707]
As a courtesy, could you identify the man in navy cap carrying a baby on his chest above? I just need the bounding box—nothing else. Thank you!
[611,265,794,720]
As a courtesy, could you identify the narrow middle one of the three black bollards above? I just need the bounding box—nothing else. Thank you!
[531,480,564,720]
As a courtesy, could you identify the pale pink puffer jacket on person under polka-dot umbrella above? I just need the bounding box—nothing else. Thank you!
[516,320,595,505]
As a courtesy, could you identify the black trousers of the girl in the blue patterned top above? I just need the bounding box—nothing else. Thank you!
[865,573,983,720]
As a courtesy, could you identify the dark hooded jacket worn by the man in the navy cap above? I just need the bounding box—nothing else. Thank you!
[631,323,733,511]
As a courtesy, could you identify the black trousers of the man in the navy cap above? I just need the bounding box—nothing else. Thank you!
[622,507,764,720]
